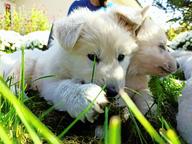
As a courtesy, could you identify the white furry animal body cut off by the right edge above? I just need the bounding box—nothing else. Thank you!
[172,51,192,144]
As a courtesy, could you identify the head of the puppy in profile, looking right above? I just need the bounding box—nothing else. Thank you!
[128,17,177,76]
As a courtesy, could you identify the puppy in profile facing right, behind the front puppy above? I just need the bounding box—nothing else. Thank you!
[126,17,177,113]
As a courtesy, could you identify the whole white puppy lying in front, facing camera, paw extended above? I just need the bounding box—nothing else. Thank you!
[0,8,151,122]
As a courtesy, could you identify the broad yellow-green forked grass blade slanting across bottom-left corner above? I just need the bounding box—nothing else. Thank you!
[0,74,60,144]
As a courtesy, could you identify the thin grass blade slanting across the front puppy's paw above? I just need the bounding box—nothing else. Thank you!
[58,86,105,138]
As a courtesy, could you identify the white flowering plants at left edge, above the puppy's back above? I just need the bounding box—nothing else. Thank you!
[0,30,49,53]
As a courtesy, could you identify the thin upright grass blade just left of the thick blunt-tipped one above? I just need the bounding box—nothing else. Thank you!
[104,107,109,144]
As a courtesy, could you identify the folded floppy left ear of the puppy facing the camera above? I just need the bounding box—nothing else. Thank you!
[55,18,84,50]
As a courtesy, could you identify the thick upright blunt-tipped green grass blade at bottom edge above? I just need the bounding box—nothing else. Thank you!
[109,116,121,144]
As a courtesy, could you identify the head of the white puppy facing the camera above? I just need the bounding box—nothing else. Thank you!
[55,9,137,95]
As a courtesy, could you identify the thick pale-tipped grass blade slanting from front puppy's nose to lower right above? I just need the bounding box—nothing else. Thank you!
[119,90,166,144]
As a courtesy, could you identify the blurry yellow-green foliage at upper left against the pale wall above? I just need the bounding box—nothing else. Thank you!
[0,9,50,34]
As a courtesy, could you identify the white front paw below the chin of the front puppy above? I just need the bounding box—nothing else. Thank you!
[73,84,108,122]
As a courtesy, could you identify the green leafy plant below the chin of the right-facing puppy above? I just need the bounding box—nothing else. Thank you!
[149,75,185,114]
